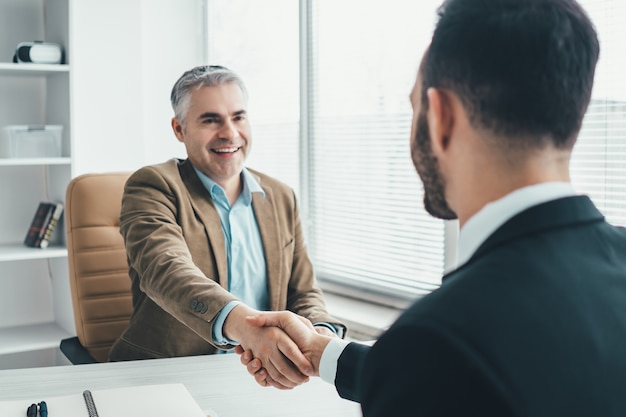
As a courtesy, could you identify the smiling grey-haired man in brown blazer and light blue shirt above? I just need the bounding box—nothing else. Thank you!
[110,66,345,387]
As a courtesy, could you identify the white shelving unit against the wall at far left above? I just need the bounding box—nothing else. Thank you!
[0,0,74,369]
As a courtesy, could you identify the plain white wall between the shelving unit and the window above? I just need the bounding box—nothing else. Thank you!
[68,0,205,176]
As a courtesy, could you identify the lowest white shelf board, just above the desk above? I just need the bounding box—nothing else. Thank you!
[0,323,73,355]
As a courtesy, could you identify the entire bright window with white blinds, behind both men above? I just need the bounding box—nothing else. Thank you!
[207,0,626,306]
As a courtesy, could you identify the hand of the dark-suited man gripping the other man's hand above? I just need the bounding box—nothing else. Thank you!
[235,311,335,388]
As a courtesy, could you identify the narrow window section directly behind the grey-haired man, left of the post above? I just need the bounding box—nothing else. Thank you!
[207,0,300,192]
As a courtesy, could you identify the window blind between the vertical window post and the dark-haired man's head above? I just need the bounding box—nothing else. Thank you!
[307,0,444,298]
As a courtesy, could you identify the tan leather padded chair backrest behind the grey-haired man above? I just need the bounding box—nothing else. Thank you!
[65,173,133,362]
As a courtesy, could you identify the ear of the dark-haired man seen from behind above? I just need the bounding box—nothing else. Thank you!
[426,87,454,155]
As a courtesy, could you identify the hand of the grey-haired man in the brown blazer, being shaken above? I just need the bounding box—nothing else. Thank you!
[223,304,313,389]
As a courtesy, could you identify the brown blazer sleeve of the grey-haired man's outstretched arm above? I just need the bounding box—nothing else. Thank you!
[120,167,236,343]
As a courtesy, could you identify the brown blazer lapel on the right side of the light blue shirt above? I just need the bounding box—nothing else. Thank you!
[252,184,283,310]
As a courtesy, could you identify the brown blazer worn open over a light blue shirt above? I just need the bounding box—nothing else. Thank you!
[110,159,343,361]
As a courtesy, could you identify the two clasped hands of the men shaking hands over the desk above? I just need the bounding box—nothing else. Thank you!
[224,306,337,389]
